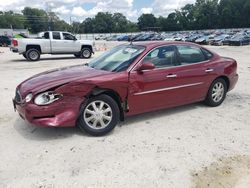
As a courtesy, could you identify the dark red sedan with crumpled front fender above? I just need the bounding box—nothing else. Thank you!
[13,42,238,136]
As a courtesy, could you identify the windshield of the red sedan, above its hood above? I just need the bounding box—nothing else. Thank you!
[88,45,145,72]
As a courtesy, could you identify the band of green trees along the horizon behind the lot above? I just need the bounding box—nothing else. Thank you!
[0,0,250,33]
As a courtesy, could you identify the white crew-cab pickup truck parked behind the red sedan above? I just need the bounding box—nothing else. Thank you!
[10,31,94,61]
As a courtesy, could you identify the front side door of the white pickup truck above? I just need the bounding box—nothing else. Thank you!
[62,33,80,52]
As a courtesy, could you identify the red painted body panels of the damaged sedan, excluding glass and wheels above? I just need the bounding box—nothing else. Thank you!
[14,42,238,127]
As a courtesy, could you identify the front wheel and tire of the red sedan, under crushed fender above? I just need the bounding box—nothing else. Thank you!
[77,94,120,136]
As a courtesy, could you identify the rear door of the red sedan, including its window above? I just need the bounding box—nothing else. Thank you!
[172,45,217,104]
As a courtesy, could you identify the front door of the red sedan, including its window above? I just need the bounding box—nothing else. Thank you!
[128,46,183,115]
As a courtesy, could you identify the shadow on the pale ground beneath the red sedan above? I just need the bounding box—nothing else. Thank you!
[14,103,206,141]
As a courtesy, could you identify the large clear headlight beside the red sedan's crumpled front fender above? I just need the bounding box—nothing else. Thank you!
[34,91,62,105]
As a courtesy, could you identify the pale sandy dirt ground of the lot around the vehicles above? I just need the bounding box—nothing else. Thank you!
[0,43,250,188]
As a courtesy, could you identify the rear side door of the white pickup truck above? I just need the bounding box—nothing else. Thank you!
[51,31,66,53]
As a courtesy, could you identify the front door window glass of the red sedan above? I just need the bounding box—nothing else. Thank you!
[142,46,175,68]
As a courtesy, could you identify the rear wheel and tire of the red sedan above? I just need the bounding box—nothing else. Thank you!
[205,78,228,107]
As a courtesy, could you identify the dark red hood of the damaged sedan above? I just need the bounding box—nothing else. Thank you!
[18,65,112,96]
